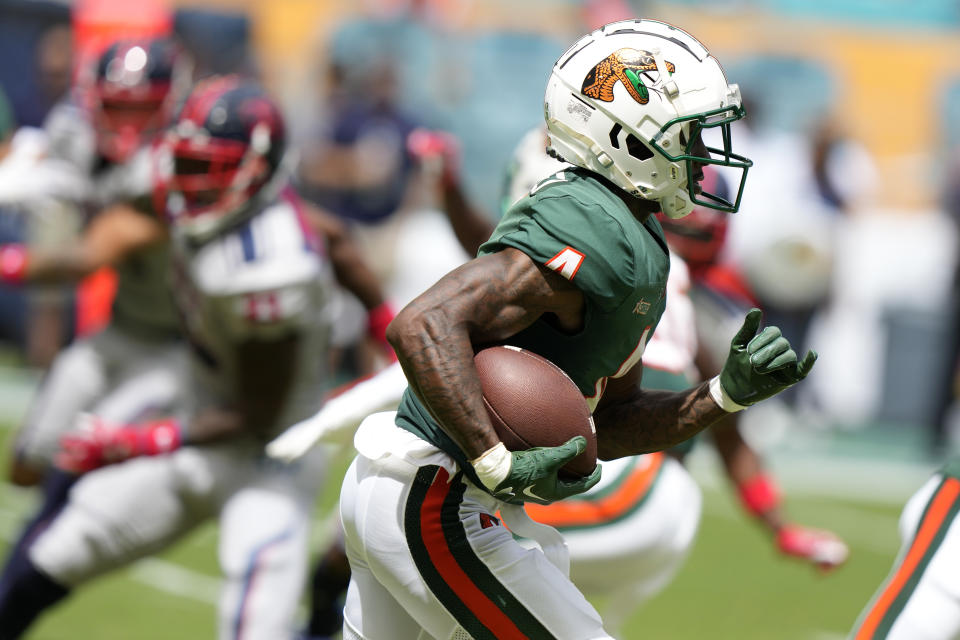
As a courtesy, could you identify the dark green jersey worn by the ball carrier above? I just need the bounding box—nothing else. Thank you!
[397,168,670,482]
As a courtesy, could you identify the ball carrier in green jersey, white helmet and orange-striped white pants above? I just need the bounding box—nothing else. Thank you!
[340,20,816,639]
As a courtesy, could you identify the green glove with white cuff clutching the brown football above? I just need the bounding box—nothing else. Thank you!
[474,436,600,504]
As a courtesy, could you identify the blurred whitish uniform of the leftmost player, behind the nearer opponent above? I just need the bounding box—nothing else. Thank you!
[15,102,187,469]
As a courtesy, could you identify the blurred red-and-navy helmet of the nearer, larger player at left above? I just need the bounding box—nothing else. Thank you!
[163,76,286,239]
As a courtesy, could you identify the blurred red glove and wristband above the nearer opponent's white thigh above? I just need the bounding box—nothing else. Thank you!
[55,414,181,473]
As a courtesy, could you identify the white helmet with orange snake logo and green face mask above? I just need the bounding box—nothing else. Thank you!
[544,20,753,218]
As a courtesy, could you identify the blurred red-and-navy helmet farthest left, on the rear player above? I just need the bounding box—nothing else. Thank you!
[86,38,192,162]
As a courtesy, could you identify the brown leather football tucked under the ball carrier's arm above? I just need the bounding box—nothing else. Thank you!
[474,346,597,477]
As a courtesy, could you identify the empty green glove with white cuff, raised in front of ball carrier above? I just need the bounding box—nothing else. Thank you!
[710,309,817,411]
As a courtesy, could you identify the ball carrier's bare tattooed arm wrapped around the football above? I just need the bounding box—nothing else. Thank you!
[387,249,584,459]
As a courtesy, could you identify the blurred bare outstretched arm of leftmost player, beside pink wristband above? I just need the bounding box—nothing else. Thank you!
[23,204,167,284]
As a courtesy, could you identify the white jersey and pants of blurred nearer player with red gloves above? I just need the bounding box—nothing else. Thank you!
[30,195,333,640]
